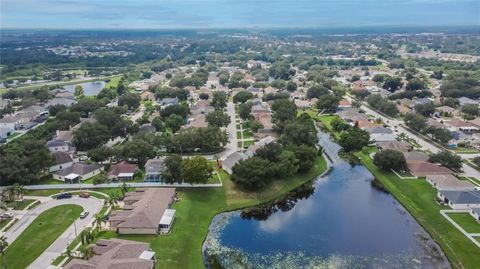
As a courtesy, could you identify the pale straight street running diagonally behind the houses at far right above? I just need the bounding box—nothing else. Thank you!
[346,96,480,178]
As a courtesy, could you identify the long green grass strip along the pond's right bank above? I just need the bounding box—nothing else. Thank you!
[356,152,480,268]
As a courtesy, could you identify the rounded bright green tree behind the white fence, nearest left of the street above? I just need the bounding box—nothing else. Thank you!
[180,156,213,183]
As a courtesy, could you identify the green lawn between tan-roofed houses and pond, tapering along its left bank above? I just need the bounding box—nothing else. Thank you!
[94,156,327,269]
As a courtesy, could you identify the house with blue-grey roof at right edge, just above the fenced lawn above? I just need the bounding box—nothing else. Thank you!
[437,190,480,209]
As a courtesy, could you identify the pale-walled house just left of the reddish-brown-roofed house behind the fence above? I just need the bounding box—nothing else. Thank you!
[52,163,103,183]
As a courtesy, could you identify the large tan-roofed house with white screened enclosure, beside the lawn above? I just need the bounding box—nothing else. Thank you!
[108,188,175,234]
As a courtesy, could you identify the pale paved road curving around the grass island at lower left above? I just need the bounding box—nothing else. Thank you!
[5,196,103,269]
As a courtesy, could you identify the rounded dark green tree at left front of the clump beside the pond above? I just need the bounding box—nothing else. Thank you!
[231,157,272,190]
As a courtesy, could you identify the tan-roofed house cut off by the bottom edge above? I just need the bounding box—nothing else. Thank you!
[64,238,155,269]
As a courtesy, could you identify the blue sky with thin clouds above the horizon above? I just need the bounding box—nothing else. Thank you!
[0,0,480,29]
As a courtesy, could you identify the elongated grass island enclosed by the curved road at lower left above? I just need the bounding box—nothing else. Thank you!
[0,205,83,268]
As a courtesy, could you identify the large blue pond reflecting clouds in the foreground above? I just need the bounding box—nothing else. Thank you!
[203,133,450,268]
